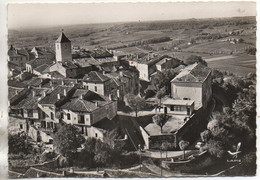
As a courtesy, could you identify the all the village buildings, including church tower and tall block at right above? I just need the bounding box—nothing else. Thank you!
[8,32,212,153]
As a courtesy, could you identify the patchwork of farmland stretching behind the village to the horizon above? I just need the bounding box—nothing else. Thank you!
[8,17,256,75]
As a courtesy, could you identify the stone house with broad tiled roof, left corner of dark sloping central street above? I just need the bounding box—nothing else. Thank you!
[60,89,117,139]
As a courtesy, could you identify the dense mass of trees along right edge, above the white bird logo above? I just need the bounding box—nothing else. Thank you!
[201,72,256,158]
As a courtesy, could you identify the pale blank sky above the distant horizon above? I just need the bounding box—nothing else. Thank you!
[7,2,256,29]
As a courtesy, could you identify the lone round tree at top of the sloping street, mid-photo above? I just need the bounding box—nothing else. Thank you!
[126,94,146,118]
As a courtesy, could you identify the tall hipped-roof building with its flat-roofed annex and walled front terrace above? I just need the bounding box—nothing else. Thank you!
[140,63,212,149]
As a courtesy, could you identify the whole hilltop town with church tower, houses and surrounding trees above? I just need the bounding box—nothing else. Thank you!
[8,16,256,178]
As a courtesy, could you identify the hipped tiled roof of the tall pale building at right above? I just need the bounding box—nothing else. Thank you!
[171,63,211,82]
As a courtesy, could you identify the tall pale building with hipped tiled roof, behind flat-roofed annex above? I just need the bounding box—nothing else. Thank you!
[171,63,212,110]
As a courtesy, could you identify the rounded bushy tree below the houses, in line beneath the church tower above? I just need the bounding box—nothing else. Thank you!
[53,124,84,161]
